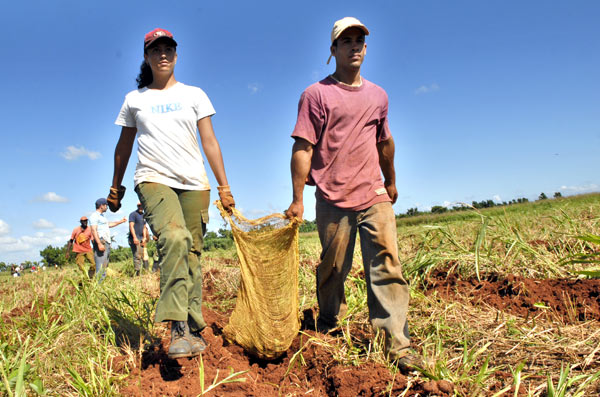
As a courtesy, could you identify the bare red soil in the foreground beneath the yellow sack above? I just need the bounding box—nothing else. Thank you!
[119,309,453,397]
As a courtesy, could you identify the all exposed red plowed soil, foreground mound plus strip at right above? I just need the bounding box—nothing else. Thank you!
[118,272,600,397]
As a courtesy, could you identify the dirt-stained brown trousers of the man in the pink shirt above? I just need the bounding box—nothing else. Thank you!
[316,194,410,359]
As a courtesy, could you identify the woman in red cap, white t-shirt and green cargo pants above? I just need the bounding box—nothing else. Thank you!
[108,29,235,358]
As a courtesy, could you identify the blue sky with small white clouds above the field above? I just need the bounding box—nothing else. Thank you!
[0,0,600,262]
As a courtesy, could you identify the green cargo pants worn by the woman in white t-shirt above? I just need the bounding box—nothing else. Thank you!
[135,182,210,332]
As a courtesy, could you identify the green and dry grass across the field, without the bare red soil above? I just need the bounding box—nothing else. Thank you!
[0,194,600,396]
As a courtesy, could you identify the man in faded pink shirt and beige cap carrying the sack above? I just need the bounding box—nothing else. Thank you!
[286,17,418,369]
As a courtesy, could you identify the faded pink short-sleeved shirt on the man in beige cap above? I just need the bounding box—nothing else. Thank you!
[292,76,392,211]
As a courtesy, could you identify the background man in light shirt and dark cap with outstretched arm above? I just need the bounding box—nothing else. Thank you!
[90,198,127,282]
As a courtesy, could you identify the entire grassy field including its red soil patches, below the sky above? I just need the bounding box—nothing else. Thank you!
[0,194,600,396]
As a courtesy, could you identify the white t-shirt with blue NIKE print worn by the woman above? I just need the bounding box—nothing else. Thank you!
[115,82,215,190]
